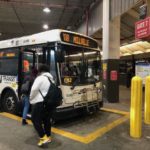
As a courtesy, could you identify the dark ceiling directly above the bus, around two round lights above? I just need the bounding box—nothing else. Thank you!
[0,0,98,40]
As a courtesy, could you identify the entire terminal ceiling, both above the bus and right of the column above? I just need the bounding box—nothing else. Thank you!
[0,0,150,55]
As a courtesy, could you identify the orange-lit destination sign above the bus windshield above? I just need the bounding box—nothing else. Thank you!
[60,32,98,48]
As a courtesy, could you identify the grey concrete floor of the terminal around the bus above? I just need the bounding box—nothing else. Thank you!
[0,87,150,150]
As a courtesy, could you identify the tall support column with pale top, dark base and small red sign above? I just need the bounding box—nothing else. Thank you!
[102,0,120,103]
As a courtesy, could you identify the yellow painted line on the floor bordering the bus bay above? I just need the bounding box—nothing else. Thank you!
[0,108,129,144]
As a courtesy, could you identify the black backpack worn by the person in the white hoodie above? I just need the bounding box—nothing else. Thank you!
[40,76,63,107]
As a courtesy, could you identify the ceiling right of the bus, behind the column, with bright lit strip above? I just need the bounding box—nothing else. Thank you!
[93,0,150,56]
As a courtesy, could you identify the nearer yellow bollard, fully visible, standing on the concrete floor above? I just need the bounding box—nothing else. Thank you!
[130,76,142,138]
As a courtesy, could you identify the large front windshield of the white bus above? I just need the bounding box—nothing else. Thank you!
[60,45,101,86]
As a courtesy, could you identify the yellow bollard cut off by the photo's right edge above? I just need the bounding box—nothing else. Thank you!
[144,76,150,124]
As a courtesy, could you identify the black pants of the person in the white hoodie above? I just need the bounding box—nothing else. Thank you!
[32,102,54,138]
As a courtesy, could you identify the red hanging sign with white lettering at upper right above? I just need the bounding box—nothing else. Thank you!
[135,17,150,39]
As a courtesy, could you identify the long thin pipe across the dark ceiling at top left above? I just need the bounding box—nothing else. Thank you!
[0,0,83,9]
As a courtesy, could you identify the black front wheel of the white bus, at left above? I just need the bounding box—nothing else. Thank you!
[2,91,17,114]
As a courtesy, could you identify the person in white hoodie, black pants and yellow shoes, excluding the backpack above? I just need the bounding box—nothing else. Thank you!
[30,64,55,146]
